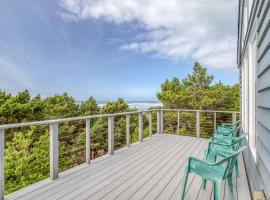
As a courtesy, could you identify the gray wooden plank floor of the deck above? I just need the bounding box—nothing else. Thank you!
[6,134,250,200]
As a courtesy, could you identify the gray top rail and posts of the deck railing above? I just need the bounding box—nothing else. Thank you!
[0,109,239,199]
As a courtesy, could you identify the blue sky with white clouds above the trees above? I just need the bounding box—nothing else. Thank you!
[0,0,238,101]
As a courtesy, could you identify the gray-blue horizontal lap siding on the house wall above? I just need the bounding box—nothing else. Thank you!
[241,0,270,199]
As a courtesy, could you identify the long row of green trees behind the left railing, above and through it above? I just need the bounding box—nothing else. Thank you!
[0,93,135,194]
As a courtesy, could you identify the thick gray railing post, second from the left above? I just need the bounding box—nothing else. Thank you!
[50,123,59,180]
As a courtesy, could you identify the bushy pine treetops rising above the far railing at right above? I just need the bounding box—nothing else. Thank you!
[157,63,239,110]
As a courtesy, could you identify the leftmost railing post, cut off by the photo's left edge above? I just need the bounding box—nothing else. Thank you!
[0,129,5,200]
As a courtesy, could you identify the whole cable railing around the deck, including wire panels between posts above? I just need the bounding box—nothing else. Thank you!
[0,109,239,194]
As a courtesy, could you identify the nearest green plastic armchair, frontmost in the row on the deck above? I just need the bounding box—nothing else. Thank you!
[181,147,246,200]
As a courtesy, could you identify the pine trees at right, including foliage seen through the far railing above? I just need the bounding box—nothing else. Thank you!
[157,63,239,137]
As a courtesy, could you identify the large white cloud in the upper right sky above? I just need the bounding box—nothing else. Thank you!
[59,0,237,68]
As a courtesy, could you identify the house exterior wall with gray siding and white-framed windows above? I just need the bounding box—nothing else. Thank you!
[237,0,270,199]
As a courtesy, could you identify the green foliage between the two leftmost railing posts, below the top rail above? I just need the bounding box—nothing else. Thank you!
[5,127,49,193]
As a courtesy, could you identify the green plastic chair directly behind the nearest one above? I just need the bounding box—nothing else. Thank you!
[205,133,247,177]
